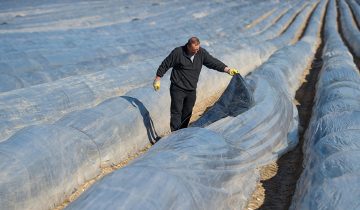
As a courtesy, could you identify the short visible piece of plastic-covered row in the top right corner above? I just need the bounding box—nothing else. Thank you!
[339,0,360,57]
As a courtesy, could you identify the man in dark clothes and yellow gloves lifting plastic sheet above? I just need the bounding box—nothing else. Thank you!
[153,37,239,131]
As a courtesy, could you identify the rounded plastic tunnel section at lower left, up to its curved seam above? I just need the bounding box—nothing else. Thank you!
[0,125,100,209]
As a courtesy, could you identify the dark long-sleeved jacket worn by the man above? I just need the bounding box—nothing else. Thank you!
[156,45,226,90]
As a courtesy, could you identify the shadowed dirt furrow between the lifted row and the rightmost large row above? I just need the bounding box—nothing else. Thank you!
[246,28,323,210]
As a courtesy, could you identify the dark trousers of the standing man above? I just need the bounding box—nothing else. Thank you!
[170,84,196,131]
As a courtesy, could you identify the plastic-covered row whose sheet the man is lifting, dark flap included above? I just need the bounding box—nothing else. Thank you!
[67,1,327,209]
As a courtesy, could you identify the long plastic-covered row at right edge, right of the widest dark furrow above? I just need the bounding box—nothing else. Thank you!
[291,1,360,209]
